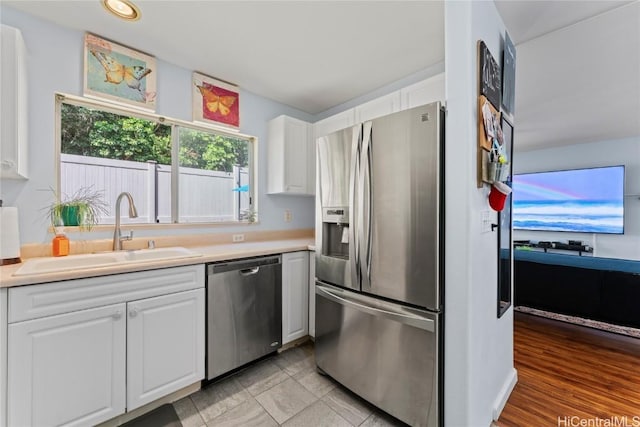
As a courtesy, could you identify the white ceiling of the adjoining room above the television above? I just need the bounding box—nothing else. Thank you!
[498,1,640,152]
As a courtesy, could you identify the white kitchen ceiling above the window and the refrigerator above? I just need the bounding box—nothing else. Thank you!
[3,0,444,114]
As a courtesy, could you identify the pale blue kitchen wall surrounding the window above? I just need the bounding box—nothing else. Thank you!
[0,5,315,244]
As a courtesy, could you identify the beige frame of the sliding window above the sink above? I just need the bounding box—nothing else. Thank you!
[53,92,258,231]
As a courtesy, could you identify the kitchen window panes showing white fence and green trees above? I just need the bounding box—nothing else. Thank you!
[56,95,255,224]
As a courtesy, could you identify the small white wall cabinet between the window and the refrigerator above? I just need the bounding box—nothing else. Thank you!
[267,116,315,195]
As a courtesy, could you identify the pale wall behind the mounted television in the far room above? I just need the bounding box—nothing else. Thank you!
[513,136,640,260]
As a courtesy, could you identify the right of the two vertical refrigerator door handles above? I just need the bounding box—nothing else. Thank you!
[358,122,372,289]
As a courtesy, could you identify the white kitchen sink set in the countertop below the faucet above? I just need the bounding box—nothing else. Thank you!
[13,247,202,276]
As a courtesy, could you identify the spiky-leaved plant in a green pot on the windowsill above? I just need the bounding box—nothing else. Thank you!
[47,187,108,230]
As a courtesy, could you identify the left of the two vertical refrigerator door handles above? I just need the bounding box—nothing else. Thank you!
[349,125,361,289]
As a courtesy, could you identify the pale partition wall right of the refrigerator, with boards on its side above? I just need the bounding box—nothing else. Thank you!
[444,1,516,427]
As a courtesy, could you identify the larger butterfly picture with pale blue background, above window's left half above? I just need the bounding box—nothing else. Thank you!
[84,33,158,112]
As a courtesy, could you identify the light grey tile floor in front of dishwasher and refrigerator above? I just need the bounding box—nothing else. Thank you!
[173,342,404,427]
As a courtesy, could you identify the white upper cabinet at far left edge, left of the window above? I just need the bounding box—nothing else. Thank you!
[0,25,29,179]
